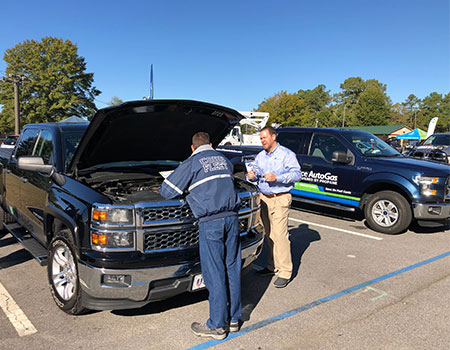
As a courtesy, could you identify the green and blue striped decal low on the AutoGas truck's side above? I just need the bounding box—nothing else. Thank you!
[291,182,361,207]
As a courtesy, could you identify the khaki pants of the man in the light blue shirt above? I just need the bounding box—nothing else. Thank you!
[261,194,292,279]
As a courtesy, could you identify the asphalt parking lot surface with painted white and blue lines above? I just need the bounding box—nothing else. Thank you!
[0,206,450,349]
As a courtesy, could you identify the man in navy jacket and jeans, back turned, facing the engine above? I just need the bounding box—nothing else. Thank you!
[160,132,242,339]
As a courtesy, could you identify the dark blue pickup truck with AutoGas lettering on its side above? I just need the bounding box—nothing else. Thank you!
[221,127,450,234]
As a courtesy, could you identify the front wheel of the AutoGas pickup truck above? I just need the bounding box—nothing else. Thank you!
[364,191,412,235]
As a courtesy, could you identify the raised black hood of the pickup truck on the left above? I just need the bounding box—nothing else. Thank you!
[69,100,243,172]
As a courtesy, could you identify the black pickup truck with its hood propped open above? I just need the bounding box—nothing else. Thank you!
[0,100,263,314]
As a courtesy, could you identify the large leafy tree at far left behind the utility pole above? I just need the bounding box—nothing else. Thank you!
[0,37,100,131]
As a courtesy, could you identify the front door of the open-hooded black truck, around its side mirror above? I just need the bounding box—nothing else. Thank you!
[21,129,54,242]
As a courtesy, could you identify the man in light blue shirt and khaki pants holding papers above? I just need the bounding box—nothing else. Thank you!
[247,126,302,288]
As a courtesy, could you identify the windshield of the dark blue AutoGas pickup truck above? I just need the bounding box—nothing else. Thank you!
[343,132,402,157]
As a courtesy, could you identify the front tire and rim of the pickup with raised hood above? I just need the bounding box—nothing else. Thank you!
[47,231,86,315]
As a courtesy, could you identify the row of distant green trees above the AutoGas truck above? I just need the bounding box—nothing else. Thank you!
[256,77,450,132]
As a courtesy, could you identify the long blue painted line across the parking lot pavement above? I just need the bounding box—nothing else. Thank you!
[187,251,450,350]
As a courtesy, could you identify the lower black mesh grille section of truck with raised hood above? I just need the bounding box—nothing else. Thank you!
[144,217,249,253]
